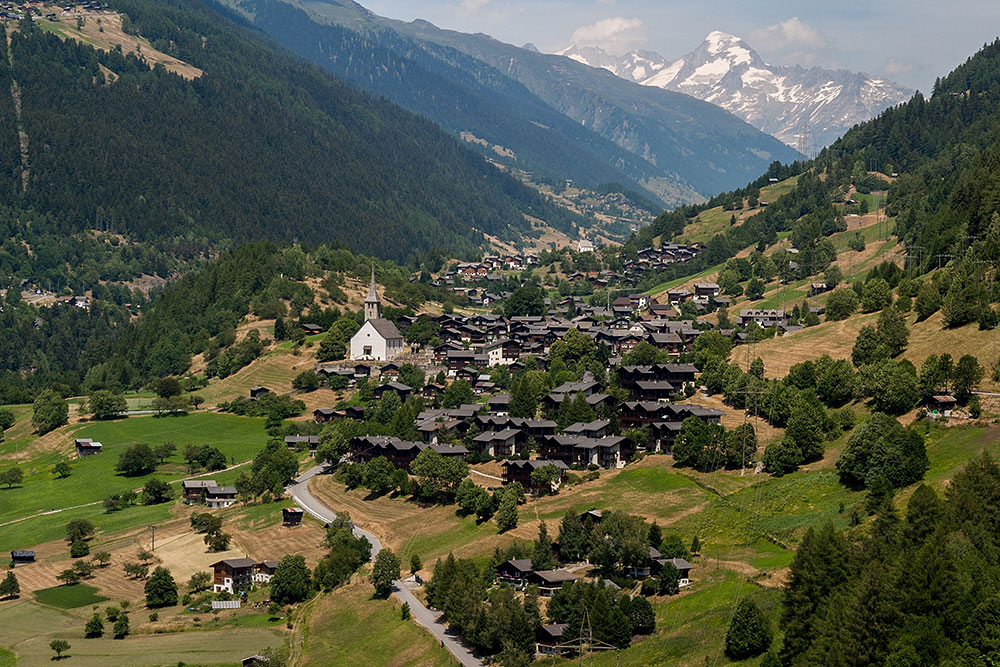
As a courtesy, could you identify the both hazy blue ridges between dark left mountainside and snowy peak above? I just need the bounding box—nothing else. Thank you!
[224,0,799,205]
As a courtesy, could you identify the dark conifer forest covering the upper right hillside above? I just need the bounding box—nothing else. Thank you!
[630,42,1000,302]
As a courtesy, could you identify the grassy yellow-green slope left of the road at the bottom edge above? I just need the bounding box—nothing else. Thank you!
[298,568,458,667]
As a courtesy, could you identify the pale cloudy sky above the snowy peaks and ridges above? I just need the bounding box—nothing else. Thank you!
[361,0,1000,92]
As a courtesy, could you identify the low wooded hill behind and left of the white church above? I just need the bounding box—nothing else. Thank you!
[0,242,440,404]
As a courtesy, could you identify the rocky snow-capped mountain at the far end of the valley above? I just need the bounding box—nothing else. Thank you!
[557,31,913,152]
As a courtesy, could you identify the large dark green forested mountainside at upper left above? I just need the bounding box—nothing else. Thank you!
[0,0,571,259]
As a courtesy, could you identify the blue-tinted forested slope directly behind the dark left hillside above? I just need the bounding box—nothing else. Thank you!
[228,0,662,205]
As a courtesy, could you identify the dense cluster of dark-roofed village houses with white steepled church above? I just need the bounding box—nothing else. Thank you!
[304,275,722,492]
